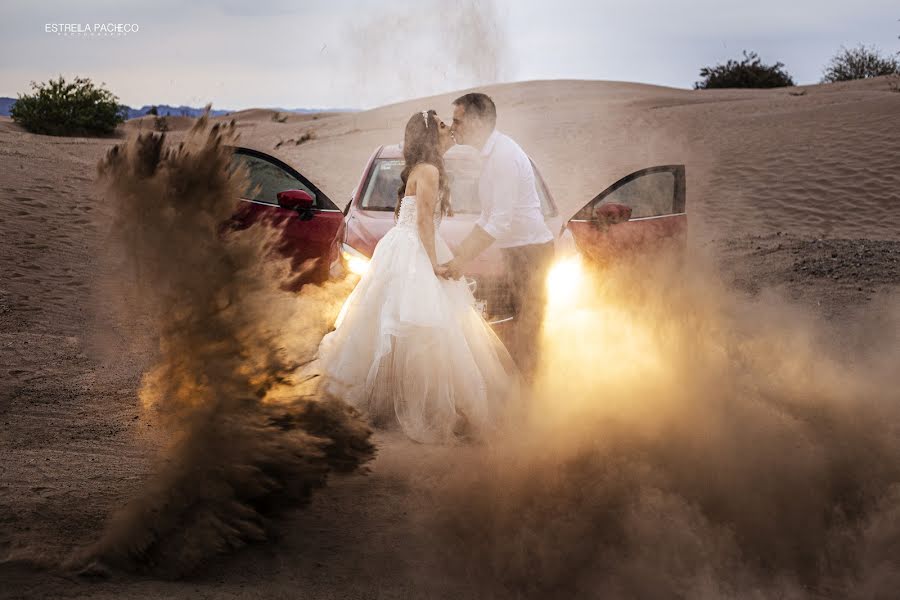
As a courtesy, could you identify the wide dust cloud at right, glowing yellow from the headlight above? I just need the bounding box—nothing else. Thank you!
[420,247,900,598]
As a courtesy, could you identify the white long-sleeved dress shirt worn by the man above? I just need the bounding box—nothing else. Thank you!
[477,129,553,248]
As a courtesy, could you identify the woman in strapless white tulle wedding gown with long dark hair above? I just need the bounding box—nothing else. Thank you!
[319,110,519,443]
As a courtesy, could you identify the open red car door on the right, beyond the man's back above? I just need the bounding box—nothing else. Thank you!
[566,165,687,262]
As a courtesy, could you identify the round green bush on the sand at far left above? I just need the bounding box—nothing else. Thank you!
[10,75,125,135]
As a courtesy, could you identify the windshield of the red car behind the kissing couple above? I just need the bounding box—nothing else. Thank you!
[361,158,553,216]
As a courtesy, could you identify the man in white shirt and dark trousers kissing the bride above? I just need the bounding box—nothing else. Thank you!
[443,93,553,379]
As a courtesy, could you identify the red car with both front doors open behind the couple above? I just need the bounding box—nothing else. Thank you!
[229,145,687,324]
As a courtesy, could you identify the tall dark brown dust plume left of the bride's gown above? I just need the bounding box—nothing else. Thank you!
[71,116,373,576]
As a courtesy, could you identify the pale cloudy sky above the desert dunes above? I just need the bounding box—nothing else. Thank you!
[0,0,900,109]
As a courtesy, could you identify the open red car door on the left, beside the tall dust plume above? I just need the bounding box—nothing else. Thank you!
[231,147,344,287]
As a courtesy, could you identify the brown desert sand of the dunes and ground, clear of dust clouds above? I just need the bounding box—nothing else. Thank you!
[0,78,900,598]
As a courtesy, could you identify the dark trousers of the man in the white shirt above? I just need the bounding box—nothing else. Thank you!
[502,241,553,381]
